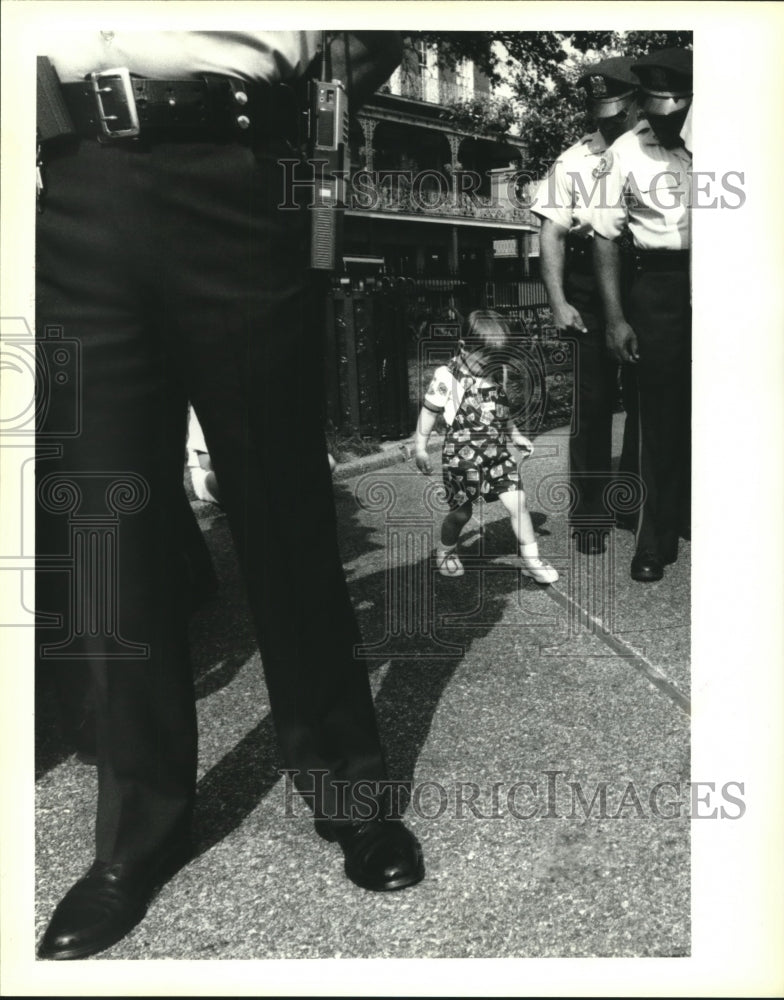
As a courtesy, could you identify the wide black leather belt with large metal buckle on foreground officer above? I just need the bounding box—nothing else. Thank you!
[57,68,301,143]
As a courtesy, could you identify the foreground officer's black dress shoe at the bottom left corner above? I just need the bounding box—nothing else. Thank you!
[38,846,190,959]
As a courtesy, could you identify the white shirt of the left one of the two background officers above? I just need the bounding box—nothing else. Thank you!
[531,132,607,237]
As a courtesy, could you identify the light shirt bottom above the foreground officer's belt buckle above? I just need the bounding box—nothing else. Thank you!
[38,30,321,83]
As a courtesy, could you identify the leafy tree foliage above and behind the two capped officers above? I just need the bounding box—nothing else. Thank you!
[407,31,692,176]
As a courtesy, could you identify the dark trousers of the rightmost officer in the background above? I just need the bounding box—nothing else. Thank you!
[628,262,691,563]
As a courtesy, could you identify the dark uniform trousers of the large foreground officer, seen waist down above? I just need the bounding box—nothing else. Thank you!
[36,140,384,861]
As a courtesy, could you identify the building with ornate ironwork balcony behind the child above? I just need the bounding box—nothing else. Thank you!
[344,42,538,300]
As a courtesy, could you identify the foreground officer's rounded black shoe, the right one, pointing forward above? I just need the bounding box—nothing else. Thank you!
[319,819,425,892]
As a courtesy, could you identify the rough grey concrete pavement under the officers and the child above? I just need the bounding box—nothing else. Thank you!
[31,414,690,960]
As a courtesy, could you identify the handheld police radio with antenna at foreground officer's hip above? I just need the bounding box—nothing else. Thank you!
[308,33,349,271]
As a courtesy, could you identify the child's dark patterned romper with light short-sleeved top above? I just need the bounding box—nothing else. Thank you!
[424,360,520,510]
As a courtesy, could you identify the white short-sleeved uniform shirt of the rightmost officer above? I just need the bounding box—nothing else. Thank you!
[591,121,692,250]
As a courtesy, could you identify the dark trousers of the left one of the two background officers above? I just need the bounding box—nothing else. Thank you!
[564,239,637,524]
